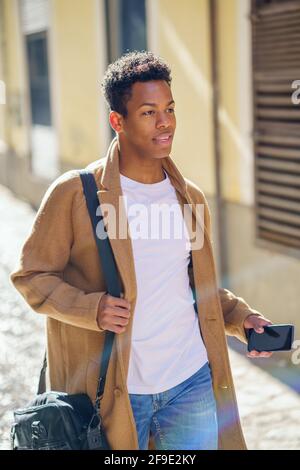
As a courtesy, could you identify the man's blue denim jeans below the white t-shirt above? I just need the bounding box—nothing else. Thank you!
[129,362,218,450]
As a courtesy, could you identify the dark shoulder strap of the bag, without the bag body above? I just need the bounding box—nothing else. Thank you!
[38,169,121,403]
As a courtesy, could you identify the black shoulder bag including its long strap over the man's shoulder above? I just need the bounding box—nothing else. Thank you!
[11,170,121,450]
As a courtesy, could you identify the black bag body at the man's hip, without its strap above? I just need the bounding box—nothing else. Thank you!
[11,392,110,450]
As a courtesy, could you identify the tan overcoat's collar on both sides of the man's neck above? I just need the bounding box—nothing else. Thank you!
[100,137,187,196]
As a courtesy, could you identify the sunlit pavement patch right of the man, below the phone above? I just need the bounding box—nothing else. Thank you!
[230,349,300,450]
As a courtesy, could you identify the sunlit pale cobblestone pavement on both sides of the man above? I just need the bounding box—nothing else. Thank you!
[0,186,300,450]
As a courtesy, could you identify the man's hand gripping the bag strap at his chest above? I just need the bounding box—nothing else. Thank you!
[97,294,130,334]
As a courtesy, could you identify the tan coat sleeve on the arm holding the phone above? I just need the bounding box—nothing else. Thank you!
[202,189,264,344]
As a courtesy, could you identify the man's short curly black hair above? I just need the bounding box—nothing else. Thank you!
[101,51,172,117]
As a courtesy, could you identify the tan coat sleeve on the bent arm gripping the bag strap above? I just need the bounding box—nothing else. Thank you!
[9,172,105,331]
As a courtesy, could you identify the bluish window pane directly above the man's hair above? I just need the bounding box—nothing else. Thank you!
[105,0,147,62]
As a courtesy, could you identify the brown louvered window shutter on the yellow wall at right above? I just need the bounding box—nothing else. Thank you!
[251,0,300,253]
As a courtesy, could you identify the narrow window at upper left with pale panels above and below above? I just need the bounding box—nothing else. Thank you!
[19,0,59,180]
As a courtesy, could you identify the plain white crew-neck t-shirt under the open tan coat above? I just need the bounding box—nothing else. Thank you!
[120,172,208,394]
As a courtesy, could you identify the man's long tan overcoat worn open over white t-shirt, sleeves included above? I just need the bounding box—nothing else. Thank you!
[10,139,258,450]
